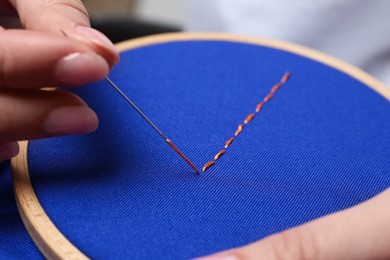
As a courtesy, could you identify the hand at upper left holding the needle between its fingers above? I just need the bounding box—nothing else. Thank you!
[0,0,119,161]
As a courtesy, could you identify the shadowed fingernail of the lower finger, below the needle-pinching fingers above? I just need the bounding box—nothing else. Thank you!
[44,106,98,135]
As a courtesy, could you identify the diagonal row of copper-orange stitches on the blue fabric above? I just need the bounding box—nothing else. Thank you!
[202,71,291,172]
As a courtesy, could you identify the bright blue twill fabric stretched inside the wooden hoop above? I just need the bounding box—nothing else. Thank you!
[0,41,390,259]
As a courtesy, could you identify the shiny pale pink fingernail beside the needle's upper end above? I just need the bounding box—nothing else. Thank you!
[54,52,109,85]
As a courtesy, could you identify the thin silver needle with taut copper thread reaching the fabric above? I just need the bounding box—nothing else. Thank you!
[106,77,200,175]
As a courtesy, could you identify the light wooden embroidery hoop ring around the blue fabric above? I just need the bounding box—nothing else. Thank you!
[11,33,390,259]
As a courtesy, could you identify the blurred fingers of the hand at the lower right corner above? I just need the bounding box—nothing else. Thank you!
[199,189,390,260]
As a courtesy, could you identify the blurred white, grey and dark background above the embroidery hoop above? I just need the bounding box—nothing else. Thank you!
[83,0,390,86]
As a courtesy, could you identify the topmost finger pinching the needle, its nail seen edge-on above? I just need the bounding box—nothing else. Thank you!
[10,0,119,66]
